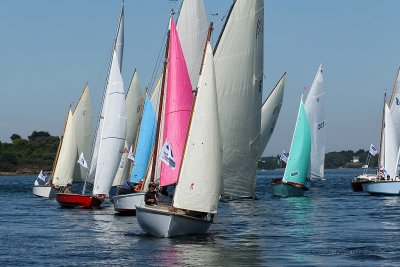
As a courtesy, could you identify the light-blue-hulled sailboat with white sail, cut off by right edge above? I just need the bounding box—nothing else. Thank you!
[362,94,400,195]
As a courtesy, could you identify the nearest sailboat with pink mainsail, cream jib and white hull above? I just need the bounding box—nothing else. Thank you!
[136,19,222,237]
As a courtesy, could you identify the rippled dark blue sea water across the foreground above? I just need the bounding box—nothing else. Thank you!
[0,169,400,266]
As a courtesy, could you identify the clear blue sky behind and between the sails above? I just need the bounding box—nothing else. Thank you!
[0,0,400,155]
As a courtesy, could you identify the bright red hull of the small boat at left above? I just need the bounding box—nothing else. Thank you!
[56,193,104,208]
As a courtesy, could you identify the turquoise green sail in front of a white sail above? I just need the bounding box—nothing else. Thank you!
[283,98,311,185]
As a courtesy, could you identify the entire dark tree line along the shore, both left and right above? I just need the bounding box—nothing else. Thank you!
[0,131,378,174]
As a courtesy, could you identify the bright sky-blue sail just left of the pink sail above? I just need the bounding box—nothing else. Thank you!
[130,94,156,183]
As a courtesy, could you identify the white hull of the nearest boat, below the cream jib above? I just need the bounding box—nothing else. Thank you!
[136,206,211,237]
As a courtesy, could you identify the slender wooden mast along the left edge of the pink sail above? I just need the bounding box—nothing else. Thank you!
[150,19,172,182]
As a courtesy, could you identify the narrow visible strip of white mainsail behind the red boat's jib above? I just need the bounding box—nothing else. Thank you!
[88,5,124,182]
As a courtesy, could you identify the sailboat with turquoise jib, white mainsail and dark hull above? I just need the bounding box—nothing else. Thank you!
[272,65,325,197]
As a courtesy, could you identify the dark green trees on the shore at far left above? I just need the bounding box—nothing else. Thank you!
[0,131,60,174]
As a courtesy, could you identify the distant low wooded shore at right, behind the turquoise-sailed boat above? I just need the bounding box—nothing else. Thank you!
[258,149,378,170]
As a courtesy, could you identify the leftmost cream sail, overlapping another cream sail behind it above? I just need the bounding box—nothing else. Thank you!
[52,109,78,186]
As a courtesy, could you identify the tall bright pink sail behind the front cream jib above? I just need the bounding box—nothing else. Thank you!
[160,18,193,186]
